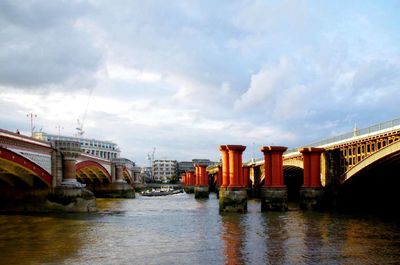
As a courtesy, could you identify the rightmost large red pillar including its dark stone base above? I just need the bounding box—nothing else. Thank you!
[299,147,324,210]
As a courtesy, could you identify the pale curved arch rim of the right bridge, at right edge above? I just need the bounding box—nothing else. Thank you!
[340,141,400,183]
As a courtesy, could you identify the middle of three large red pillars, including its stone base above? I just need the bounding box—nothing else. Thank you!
[260,146,288,212]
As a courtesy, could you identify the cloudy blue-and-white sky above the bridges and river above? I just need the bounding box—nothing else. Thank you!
[0,0,400,166]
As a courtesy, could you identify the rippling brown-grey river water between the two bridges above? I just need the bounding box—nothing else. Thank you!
[0,194,400,265]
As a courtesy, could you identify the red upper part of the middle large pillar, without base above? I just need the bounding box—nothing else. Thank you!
[260,146,287,188]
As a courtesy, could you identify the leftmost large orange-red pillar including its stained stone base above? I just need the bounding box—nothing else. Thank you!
[219,145,247,213]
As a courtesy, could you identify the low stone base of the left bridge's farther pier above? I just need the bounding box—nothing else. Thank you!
[94,181,136,199]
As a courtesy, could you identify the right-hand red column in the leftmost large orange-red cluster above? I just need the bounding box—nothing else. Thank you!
[226,145,246,188]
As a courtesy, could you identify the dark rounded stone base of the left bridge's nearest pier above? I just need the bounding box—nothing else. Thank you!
[46,185,97,212]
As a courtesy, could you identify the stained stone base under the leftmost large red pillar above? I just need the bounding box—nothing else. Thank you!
[219,188,247,213]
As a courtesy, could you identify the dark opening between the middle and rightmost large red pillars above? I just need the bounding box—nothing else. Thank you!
[283,166,303,203]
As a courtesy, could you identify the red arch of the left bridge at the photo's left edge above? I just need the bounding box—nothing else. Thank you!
[0,147,53,187]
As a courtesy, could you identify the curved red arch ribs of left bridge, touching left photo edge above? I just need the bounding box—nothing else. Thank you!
[0,147,53,187]
